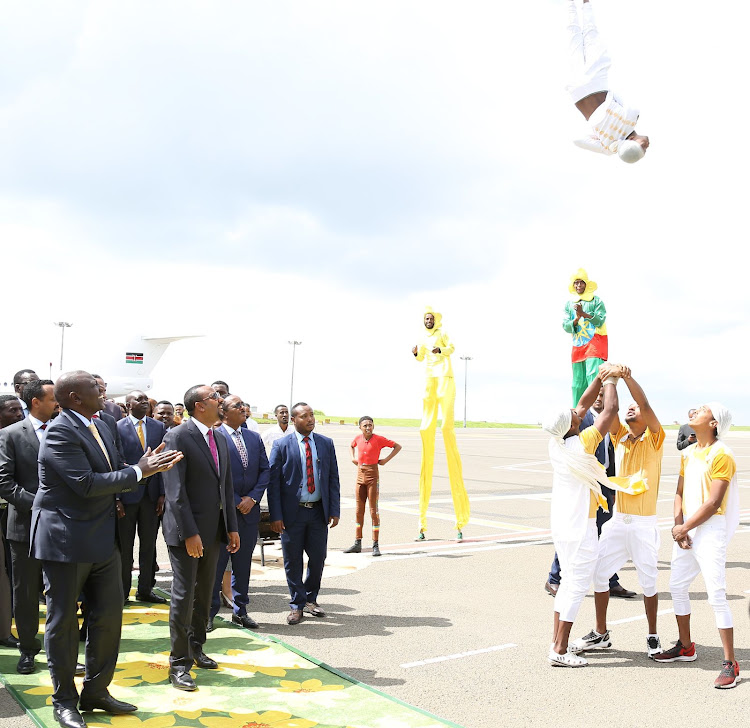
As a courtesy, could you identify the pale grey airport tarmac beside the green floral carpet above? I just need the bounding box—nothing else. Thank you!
[0,423,750,728]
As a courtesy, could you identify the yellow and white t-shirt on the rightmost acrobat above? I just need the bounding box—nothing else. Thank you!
[680,440,737,518]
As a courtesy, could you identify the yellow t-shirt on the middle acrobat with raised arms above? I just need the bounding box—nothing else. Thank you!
[612,423,666,516]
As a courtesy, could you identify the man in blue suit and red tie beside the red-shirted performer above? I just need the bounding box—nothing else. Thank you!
[268,402,341,624]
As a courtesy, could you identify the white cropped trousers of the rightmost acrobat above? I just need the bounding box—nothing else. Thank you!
[669,515,733,629]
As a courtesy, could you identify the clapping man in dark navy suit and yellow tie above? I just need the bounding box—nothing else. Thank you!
[30,371,181,728]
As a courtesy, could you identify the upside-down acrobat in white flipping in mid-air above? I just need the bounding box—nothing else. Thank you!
[565,0,649,164]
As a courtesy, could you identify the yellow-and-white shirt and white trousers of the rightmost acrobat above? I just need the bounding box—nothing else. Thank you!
[669,440,739,629]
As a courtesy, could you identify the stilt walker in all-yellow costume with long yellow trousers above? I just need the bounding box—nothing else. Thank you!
[412,308,469,539]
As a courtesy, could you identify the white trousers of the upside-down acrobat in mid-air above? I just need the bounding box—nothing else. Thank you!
[565,0,612,104]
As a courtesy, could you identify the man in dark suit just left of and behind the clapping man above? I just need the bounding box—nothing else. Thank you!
[0,379,57,675]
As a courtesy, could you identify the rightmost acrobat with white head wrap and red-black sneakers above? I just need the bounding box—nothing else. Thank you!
[654,402,740,688]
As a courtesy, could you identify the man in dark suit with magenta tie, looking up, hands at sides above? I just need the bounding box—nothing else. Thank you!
[162,384,240,690]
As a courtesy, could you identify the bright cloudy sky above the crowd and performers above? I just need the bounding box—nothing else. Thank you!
[0,0,750,424]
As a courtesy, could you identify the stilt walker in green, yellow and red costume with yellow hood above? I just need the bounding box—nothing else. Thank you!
[563,268,609,407]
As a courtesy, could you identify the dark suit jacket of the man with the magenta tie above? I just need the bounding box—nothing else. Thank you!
[162,419,237,546]
